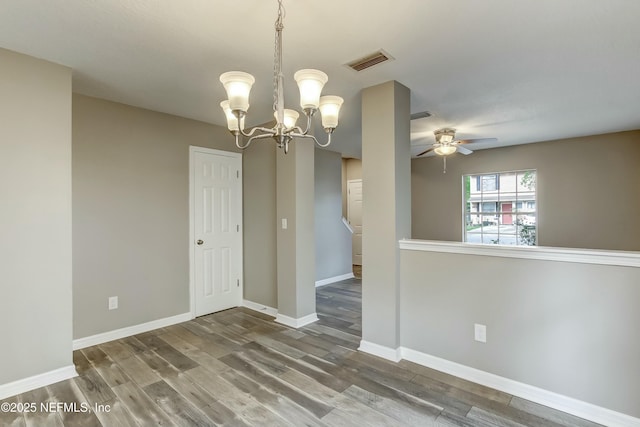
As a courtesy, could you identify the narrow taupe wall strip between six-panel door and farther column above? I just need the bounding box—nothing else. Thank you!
[242,140,278,308]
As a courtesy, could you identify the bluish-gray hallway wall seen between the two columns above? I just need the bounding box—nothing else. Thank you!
[315,149,352,281]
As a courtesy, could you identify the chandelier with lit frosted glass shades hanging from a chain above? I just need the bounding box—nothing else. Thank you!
[220,0,343,154]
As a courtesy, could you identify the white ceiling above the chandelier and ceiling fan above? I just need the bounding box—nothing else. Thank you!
[0,0,640,157]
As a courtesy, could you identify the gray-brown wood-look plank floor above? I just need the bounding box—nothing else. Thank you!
[0,280,596,427]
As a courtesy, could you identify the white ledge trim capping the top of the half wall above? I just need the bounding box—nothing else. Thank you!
[399,240,640,268]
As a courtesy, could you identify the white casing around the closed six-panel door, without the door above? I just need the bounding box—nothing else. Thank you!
[189,145,244,319]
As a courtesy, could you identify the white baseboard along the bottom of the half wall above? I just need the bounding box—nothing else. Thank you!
[400,347,640,427]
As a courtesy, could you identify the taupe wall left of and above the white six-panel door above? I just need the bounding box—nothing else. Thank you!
[73,95,236,338]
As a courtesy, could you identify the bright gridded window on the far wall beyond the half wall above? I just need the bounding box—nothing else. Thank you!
[463,170,538,246]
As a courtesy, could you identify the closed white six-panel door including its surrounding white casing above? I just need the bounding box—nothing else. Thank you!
[190,147,242,316]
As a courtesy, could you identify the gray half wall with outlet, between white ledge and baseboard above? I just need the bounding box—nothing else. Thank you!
[400,250,640,417]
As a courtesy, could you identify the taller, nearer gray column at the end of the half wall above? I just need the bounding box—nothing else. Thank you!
[359,81,411,360]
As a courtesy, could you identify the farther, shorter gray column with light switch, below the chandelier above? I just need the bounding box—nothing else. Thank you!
[276,140,318,328]
